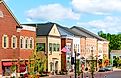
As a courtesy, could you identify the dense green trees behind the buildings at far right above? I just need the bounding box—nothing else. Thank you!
[98,31,121,51]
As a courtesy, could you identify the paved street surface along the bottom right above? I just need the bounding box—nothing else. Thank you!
[46,70,121,78]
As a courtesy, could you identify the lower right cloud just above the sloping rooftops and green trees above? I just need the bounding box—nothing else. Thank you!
[77,16,121,33]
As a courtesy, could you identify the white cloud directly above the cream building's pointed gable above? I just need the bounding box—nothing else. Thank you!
[27,4,80,20]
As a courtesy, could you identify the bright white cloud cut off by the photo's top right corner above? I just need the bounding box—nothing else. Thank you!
[71,0,121,15]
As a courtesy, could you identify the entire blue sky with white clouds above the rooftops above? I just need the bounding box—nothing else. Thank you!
[5,0,121,34]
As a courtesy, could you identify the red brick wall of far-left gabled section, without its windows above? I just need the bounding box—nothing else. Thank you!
[0,3,19,59]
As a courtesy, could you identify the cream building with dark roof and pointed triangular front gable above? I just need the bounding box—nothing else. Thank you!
[26,23,61,74]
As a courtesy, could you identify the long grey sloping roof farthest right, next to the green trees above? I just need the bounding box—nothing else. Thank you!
[71,26,107,41]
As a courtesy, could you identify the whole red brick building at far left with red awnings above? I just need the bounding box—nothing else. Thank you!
[0,0,36,78]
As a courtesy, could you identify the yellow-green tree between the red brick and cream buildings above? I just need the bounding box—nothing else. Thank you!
[29,46,47,75]
